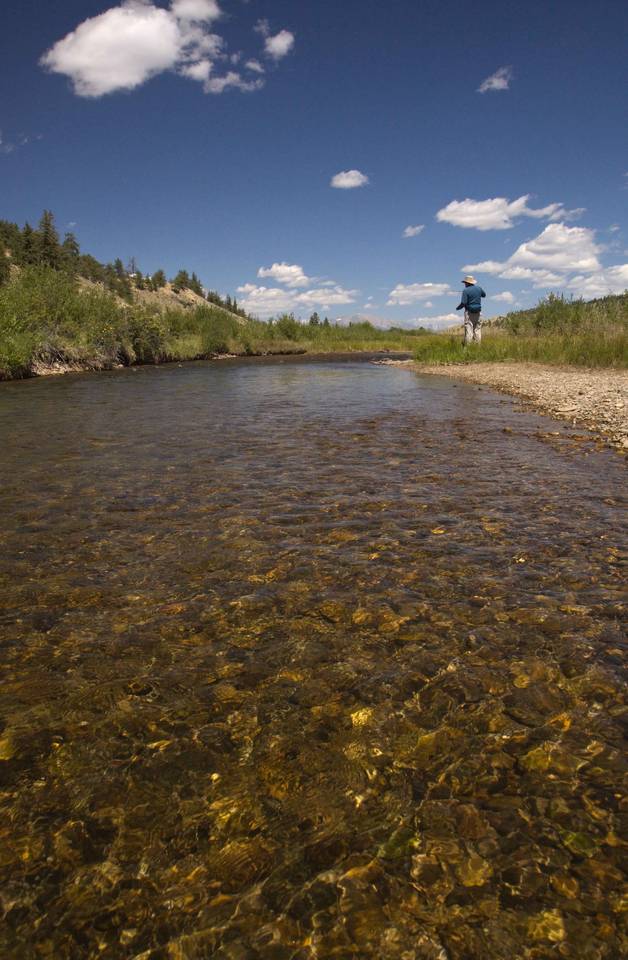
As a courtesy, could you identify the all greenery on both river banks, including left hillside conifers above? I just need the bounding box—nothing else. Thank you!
[0,211,628,380]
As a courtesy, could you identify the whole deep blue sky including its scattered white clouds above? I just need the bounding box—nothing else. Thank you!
[0,0,628,326]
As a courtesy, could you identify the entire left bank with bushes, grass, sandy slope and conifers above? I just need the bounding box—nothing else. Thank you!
[0,211,425,380]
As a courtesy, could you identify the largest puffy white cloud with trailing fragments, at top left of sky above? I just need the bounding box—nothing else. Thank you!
[40,0,294,97]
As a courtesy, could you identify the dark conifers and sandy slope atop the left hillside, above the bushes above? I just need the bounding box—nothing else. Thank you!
[0,210,248,318]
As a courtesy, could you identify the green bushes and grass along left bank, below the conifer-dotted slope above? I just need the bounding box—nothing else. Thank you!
[0,266,426,380]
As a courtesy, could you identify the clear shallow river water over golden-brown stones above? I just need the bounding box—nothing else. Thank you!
[0,360,627,960]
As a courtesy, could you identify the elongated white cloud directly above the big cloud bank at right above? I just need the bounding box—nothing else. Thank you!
[436,194,584,230]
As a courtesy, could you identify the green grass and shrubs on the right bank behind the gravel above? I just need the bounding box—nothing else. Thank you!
[414,294,628,368]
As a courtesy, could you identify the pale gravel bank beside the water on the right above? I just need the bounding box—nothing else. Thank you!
[417,363,628,451]
